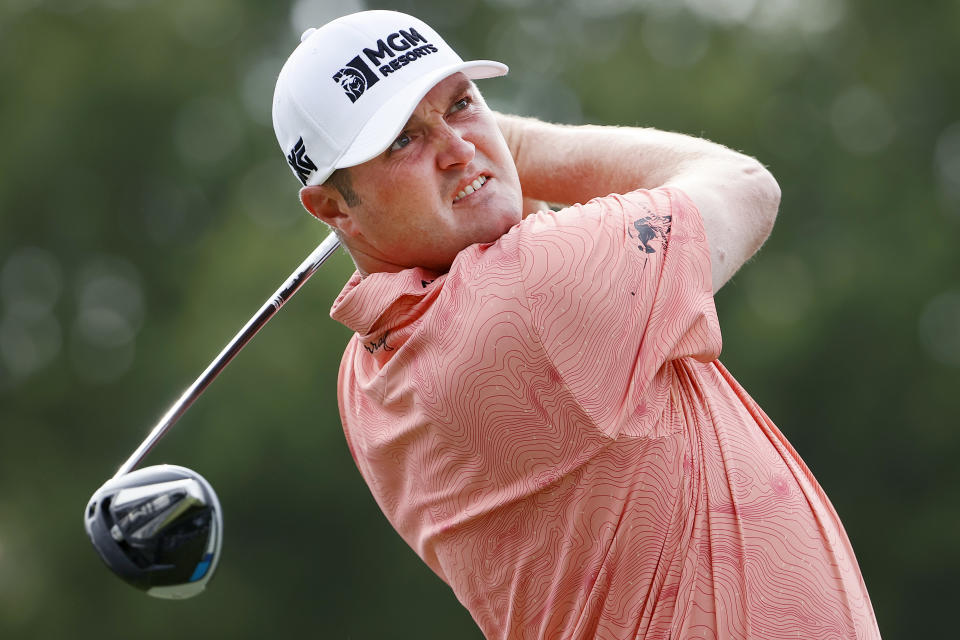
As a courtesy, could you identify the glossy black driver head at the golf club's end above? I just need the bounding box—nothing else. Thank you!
[83,464,223,599]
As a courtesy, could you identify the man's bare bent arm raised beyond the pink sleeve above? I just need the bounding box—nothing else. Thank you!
[497,114,780,292]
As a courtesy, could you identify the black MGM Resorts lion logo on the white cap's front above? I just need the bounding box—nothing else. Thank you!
[333,27,437,102]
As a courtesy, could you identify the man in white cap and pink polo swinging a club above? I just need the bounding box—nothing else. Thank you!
[274,11,879,639]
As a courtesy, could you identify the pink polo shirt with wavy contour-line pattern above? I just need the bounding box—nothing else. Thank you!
[331,189,879,640]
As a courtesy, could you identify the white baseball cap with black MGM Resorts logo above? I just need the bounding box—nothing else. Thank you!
[273,11,507,185]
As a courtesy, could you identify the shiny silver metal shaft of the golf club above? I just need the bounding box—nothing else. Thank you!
[113,233,340,478]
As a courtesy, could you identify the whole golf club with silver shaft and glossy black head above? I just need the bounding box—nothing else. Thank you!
[83,233,340,598]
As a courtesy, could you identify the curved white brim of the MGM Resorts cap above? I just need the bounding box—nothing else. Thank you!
[335,60,508,169]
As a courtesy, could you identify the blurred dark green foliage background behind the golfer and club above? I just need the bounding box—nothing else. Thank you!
[0,0,960,638]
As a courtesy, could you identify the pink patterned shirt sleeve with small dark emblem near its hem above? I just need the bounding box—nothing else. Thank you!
[515,188,721,437]
